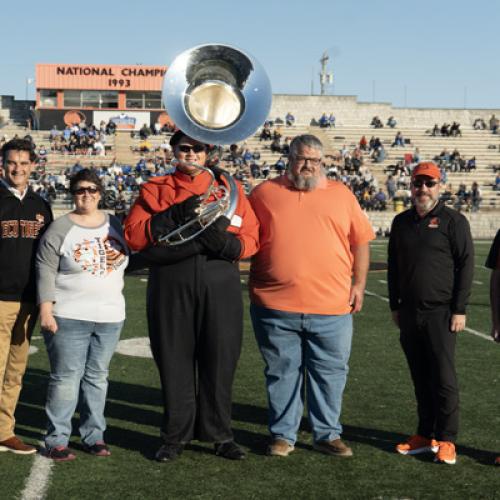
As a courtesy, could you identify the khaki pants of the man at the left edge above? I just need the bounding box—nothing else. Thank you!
[0,301,38,441]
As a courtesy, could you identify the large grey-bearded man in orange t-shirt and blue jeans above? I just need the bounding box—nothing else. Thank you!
[250,135,374,457]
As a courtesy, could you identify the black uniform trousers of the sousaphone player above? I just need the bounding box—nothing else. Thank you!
[147,255,243,443]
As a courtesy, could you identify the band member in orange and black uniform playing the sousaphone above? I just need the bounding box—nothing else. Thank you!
[125,131,259,461]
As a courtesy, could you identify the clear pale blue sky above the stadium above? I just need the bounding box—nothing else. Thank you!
[0,0,500,108]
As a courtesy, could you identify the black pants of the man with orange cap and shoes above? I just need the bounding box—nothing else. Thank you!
[399,309,458,442]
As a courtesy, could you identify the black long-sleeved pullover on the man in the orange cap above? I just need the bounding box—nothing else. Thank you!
[388,202,474,314]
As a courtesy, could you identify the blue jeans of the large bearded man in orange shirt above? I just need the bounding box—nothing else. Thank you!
[250,304,352,444]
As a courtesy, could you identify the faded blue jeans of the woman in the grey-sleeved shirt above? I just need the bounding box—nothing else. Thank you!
[43,317,123,449]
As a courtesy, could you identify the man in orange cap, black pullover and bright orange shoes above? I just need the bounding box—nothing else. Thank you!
[388,162,474,464]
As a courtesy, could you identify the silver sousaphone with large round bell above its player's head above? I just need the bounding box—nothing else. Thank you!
[160,44,272,245]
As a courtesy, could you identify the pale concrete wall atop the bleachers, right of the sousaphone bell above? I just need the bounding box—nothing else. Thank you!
[269,94,500,128]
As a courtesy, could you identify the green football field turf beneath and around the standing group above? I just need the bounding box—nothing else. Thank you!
[0,240,500,499]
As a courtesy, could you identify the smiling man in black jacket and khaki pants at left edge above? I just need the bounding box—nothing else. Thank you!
[0,139,52,455]
